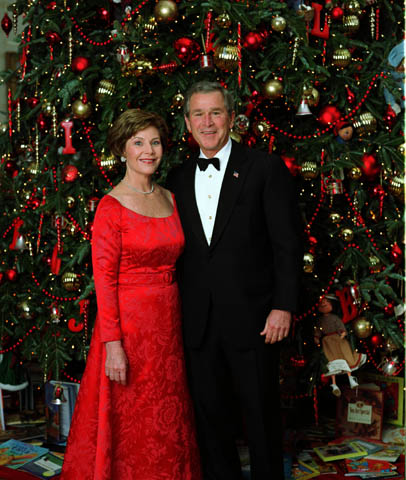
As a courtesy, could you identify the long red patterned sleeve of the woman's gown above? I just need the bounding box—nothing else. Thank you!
[92,195,121,342]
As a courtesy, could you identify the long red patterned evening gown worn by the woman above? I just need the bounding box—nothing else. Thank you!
[61,195,201,480]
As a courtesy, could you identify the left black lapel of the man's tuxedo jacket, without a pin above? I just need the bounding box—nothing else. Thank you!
[181,161,208,248]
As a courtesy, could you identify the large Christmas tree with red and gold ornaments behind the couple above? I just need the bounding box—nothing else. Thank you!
[0,0,405,404]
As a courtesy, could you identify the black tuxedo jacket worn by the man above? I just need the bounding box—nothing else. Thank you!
[167,142,302,348]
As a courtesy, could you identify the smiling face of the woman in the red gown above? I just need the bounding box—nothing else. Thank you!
[123,126,163,175]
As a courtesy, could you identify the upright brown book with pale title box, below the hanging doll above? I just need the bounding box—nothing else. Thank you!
[336,385,383,440]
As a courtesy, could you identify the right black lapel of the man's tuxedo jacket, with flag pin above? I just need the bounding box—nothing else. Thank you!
[210,142,251,249]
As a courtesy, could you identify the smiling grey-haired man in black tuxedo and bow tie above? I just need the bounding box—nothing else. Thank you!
[168,81,302,480]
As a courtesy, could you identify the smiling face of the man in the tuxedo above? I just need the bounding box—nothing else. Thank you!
[185,92,235,158]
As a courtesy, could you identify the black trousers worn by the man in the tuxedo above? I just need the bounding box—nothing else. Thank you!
[186,306,283,480]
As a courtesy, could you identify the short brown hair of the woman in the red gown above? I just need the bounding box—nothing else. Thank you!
[107,108,168,157]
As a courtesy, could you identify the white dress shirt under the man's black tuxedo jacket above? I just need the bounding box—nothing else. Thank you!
[195,138,231,245]
